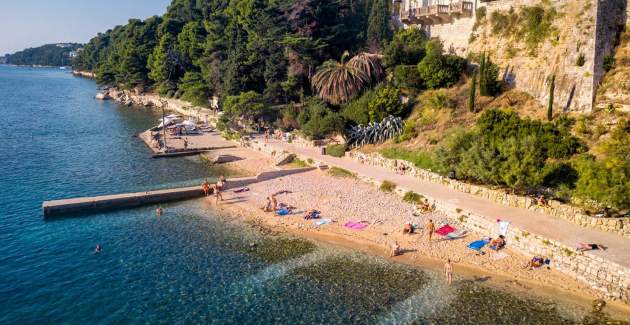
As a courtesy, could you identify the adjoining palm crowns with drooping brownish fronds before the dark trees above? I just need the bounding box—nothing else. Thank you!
[312,51,384,105]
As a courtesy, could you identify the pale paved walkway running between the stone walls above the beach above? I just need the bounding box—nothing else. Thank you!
[259,135,630,267]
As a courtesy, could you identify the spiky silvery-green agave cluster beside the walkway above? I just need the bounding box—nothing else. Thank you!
[346,115,403,148]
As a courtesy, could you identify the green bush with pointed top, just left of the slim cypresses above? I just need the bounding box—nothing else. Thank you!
[418,40,467,89]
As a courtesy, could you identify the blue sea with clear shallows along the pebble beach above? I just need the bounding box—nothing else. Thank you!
[0,66,624,324]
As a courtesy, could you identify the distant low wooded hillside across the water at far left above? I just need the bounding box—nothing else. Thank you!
[3,43,83,66]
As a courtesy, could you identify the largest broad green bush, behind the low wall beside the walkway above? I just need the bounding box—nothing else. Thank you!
[435,110,584,191]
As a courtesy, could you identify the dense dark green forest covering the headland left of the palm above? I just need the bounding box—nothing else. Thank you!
[74,0,380,103]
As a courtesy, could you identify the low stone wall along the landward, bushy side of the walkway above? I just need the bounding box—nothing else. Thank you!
[347,152,630,238]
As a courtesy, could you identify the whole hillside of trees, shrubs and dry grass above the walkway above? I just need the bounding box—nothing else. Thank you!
[74,0,630,211]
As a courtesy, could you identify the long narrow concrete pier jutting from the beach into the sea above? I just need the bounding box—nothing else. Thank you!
[42,186,203,218]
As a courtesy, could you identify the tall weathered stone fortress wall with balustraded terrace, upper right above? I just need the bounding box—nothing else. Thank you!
[393,0,628,113]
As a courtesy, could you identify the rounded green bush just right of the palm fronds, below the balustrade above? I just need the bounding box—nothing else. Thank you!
[383,28,429,68]
